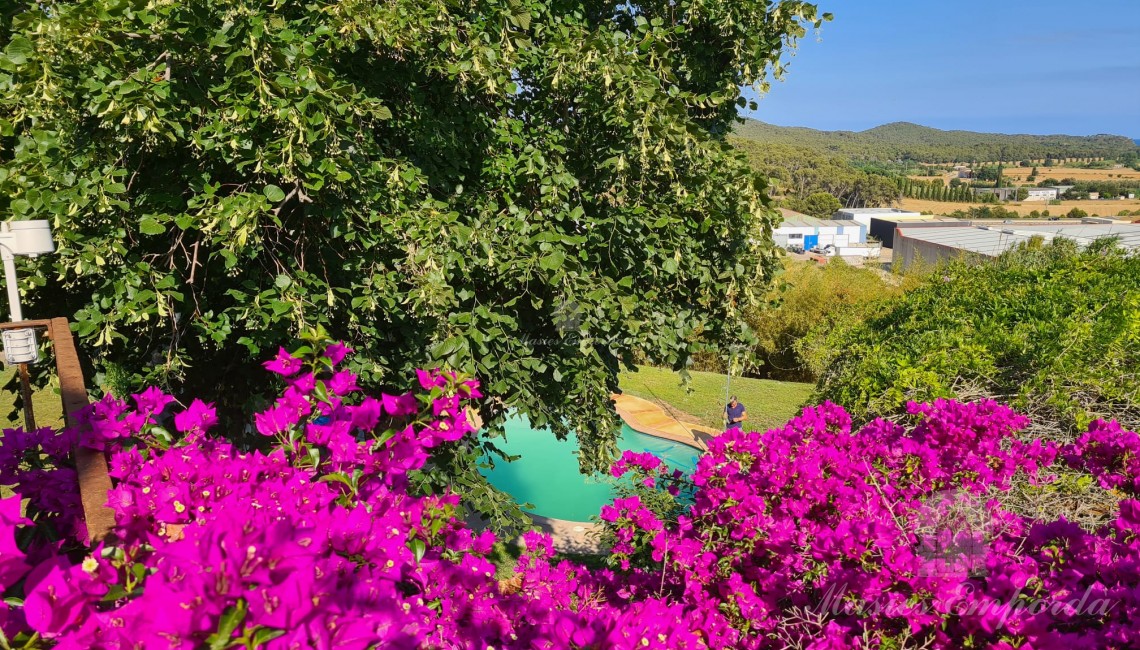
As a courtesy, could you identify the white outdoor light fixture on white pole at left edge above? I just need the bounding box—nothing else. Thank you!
[0,220,56,364]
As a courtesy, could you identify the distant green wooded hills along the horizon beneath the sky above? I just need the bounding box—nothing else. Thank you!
[734,120,1140,163]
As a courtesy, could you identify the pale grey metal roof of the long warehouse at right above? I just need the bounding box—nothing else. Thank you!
[895,224,1140,257]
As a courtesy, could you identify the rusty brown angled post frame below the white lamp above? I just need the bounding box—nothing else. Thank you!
[0,318,115,544]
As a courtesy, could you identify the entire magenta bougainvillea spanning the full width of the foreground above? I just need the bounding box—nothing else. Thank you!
[0,337,1140,650]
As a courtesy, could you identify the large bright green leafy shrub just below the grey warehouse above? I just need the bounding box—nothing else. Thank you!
[809,239,1140,439]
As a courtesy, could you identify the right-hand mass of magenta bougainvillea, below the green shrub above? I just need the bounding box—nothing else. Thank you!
[603,400,1140,648]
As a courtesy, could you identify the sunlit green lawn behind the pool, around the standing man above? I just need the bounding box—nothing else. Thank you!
[618,366,812,431]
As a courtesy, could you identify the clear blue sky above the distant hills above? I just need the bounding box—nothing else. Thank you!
[748,0,1140,138]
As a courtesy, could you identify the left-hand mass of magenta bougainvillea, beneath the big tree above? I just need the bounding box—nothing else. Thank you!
[0,346,700,649]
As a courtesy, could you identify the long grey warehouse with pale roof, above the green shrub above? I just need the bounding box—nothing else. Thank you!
[893,222,1140,270]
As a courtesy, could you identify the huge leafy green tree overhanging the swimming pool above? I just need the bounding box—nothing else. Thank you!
[0,0,829,478]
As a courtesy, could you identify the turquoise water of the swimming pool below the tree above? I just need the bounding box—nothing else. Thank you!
[481,416,700,521]
